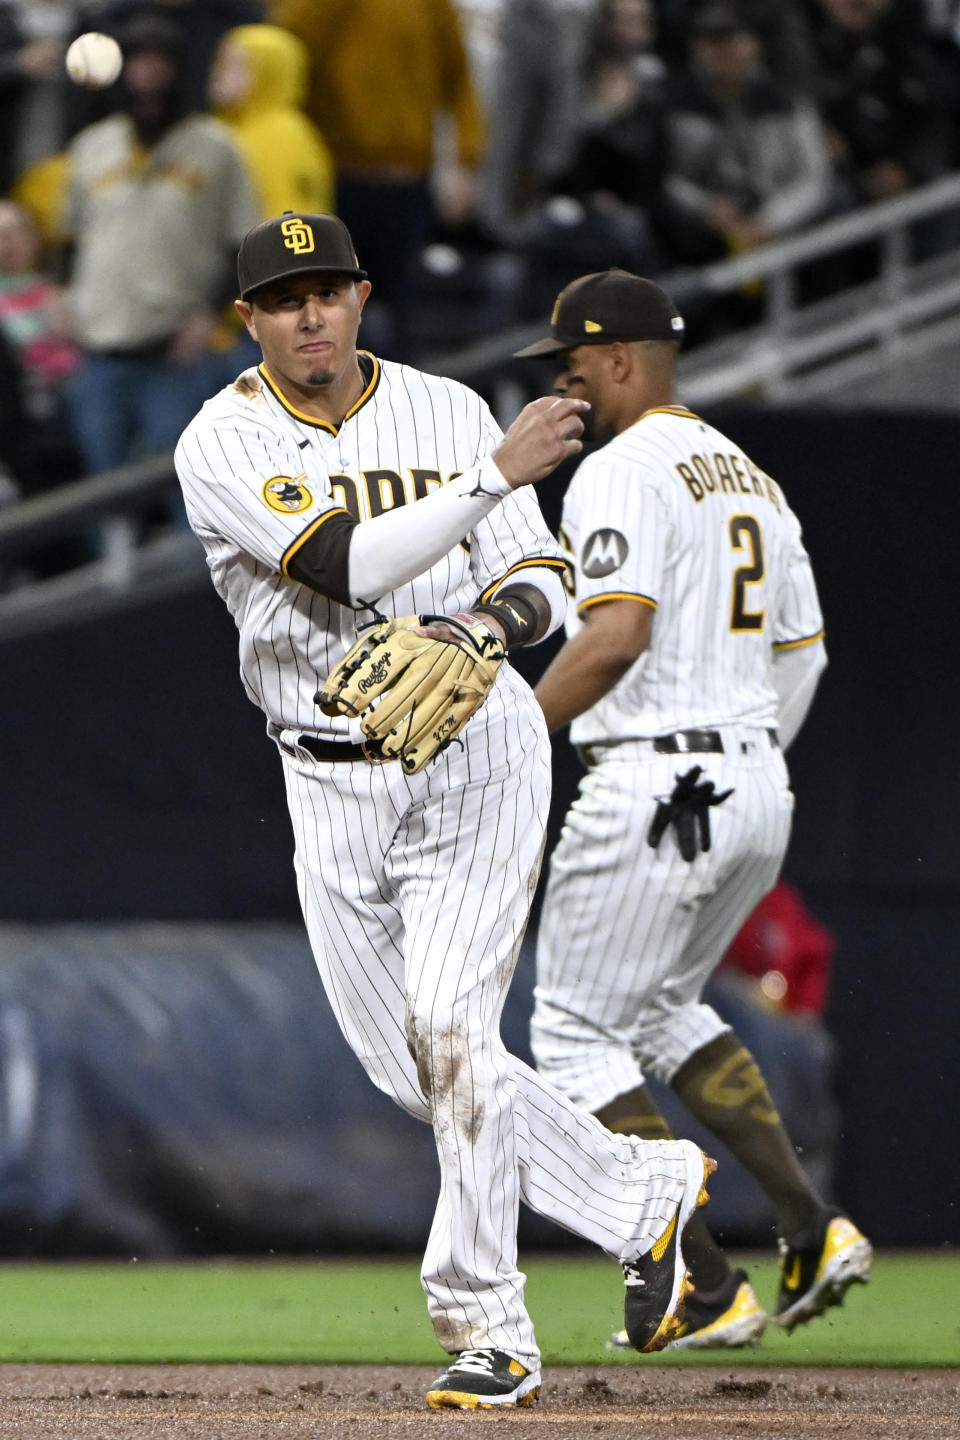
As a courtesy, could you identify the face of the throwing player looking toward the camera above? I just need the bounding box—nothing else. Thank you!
[237,271,370,393]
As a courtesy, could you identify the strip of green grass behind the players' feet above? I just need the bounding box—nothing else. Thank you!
[0,1251,960,1368]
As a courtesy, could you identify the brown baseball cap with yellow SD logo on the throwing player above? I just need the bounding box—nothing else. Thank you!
[236,210,367,300]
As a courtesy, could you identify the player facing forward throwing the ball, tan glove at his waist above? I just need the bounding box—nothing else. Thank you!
[176,213,714,1408]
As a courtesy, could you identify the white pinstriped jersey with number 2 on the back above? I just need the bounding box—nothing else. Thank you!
[560,406,823,744]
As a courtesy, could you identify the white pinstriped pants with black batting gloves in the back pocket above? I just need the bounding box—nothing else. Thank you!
[531,726,793,1110]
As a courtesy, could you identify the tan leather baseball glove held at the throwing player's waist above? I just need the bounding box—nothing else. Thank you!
[315,615,505,775]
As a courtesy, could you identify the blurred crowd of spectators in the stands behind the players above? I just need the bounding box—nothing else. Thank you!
[0,0,960,512]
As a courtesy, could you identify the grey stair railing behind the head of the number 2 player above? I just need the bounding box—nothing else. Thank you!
[425,174,960,419]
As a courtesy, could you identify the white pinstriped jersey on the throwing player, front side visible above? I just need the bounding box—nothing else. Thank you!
[176,351,561,740]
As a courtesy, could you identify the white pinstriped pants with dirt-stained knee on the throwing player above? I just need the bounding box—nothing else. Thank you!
[282,665,699,1367]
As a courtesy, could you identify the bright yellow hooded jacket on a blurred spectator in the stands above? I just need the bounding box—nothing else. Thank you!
[214,24,334,219]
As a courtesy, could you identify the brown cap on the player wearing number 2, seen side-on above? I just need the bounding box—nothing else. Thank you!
[514,269,684,357]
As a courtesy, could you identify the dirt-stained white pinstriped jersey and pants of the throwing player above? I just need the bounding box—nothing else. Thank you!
[177,357,702,1371]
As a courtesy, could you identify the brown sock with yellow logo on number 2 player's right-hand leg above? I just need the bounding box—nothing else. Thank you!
[671,1031,826,1241]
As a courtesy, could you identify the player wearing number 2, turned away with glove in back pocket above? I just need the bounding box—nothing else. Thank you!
[520,271,871,1348]
